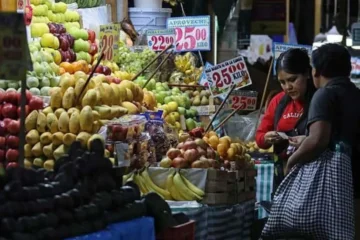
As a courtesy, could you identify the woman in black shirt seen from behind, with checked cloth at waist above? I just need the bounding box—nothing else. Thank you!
[263,44,360,240]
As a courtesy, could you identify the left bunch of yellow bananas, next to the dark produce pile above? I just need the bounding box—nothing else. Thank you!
[123,168,172,200]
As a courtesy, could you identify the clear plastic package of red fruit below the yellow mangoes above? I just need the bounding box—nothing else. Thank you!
[106,115,146,141]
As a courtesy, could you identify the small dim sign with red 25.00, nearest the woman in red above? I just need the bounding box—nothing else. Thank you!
[229,90,258,111]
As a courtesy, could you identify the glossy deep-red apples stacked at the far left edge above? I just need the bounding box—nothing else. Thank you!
[0,90,44,166]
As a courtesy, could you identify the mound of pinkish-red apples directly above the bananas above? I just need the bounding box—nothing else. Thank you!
[160,138,220,168]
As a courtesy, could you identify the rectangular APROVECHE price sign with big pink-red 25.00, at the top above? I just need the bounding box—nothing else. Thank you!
[167,16,211,52]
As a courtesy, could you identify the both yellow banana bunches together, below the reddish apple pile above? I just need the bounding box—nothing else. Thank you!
[123,169,205,201]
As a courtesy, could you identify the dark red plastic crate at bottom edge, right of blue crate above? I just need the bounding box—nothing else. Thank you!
[156,220,195,240]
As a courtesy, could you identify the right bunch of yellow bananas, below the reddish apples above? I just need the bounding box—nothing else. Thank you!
[166,172,205,201]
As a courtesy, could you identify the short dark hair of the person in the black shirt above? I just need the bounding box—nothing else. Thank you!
[312,43,352,78]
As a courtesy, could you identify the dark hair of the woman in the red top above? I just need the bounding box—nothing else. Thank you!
[276,48,316,126]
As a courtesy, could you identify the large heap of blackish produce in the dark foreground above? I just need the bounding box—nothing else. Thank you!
[0,140,171,240]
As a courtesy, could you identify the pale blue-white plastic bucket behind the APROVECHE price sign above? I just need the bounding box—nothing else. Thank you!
[129,8,172,33]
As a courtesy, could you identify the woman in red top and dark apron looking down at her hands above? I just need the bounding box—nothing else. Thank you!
[256,48,316,188]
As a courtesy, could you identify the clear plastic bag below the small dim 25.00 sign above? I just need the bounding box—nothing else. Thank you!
[224,110,263,142]
